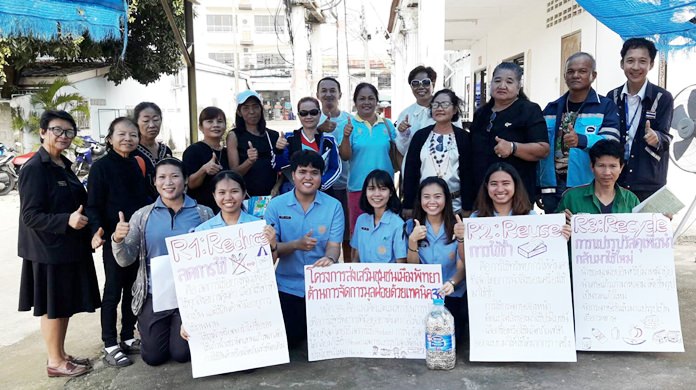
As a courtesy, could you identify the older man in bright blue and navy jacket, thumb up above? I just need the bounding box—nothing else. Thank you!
[537,52,619,214]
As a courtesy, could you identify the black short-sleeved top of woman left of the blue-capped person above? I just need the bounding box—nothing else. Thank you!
[183,141,230,213]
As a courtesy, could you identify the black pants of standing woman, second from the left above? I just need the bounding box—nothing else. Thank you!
[101,242,139,348]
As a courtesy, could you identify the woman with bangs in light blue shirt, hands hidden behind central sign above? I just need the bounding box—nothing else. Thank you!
[350,169,406,263]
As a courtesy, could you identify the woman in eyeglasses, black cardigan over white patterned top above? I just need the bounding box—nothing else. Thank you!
[404,89,475,216]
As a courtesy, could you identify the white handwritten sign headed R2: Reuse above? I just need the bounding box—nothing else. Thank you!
[464,214,577,362]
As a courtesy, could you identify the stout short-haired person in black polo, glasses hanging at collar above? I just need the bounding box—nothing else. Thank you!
[470,62,549,200]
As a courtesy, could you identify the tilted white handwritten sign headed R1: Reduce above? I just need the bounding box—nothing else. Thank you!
[167,221,289,378]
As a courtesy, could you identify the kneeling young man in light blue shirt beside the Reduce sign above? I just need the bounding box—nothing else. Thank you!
[264,150,345,348]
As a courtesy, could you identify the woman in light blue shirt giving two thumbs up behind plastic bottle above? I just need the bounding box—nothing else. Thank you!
[406,176,468,340]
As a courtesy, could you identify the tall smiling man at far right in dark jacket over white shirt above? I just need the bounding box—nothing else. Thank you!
[607,38,674,201]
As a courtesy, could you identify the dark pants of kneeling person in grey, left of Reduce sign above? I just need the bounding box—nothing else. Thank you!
[138,294,191,366]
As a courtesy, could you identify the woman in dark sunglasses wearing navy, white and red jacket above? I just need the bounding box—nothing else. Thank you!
[274,96,341,195]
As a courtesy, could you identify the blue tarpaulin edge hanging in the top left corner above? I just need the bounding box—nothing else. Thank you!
[0,0,127,41]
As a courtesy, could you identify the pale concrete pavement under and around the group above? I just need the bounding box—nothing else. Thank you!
[0,192,696,389]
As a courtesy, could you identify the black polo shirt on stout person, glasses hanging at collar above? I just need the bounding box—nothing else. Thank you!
[470,99,549,202]
